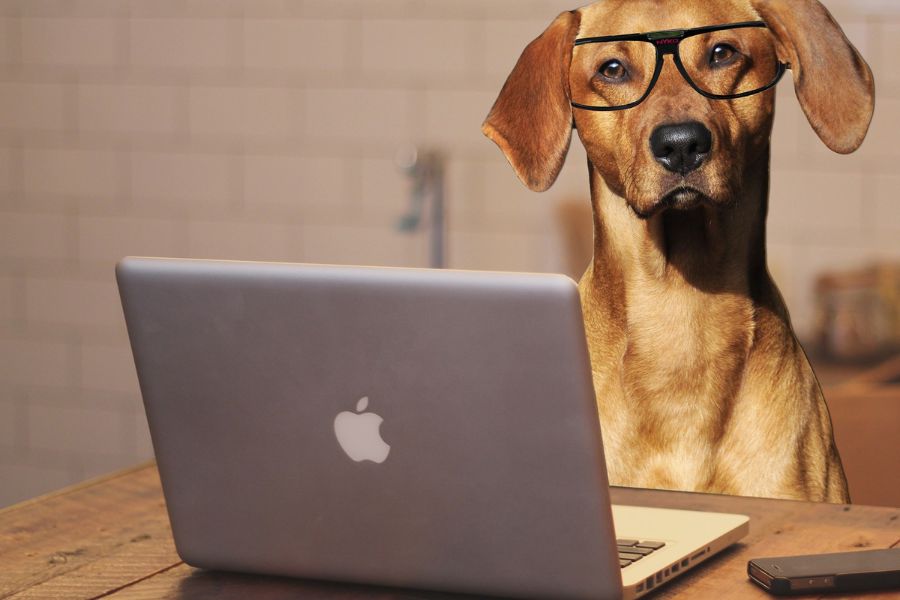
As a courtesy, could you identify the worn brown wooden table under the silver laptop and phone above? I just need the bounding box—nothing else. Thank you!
[0,464,900,600]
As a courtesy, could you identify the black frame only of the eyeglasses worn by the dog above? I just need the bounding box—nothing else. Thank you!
[571,21,791,112]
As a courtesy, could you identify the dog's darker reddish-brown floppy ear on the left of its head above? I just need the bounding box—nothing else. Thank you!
[481,11,581,192]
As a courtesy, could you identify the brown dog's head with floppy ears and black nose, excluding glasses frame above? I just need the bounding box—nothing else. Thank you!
[483,0,874,217]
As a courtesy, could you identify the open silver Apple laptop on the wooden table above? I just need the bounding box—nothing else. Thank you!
[117,258,748,600]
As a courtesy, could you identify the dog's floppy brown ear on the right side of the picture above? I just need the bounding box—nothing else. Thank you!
[751,0,875,154]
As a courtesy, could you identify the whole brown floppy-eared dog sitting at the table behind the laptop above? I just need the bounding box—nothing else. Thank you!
[483,0,874,502]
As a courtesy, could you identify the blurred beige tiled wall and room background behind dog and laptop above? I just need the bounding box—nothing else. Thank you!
[0,0,900,506]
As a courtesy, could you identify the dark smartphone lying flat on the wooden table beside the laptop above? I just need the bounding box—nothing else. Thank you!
[747,548,900,596]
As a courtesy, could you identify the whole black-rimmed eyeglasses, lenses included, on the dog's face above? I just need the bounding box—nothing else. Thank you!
[572,21,791,111]
